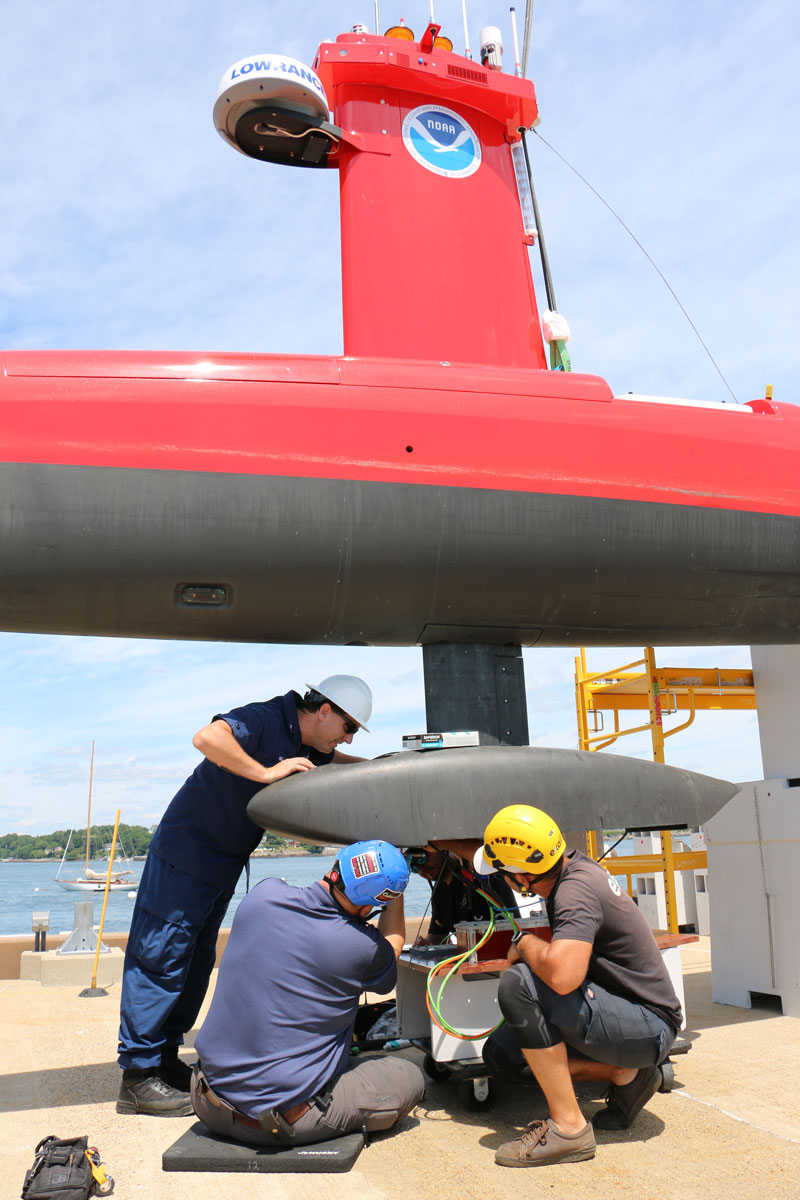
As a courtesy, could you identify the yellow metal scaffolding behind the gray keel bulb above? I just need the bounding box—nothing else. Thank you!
[575,646,756,934]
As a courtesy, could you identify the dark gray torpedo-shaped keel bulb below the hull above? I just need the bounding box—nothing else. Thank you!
[247,746,739,846]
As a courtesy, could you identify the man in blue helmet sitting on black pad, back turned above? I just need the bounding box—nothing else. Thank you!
[192,841,425,1146]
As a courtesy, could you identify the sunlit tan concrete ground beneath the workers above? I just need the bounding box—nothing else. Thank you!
[0,938,800,1200]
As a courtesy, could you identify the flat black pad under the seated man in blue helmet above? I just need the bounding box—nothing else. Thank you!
[161,1121,363,1172]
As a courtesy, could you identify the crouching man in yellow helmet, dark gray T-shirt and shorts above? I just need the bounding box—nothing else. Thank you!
[475,804,682,1166]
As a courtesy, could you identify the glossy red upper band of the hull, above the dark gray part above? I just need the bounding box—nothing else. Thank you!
[0,352,800,516]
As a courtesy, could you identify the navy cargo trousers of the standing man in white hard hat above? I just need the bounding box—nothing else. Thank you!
[118,851,233,1067]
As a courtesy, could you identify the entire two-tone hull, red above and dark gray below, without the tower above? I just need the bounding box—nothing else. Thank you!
[0,353,800,646]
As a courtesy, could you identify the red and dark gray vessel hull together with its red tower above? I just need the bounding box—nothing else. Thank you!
[0,31,800,646]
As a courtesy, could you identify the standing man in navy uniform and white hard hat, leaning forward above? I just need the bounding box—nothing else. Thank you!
[116,676,372,1116]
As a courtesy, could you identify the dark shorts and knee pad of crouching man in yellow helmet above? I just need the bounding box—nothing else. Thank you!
[483,962,675,1075]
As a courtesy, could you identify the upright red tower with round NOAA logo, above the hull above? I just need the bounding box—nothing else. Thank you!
[314,25,546,368]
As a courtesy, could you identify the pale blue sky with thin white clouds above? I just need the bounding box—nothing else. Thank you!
[0,0,800,832]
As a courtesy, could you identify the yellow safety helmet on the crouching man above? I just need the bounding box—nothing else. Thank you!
[475,804,566,875]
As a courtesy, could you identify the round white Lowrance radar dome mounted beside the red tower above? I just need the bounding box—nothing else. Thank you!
[213,54,342,167]
